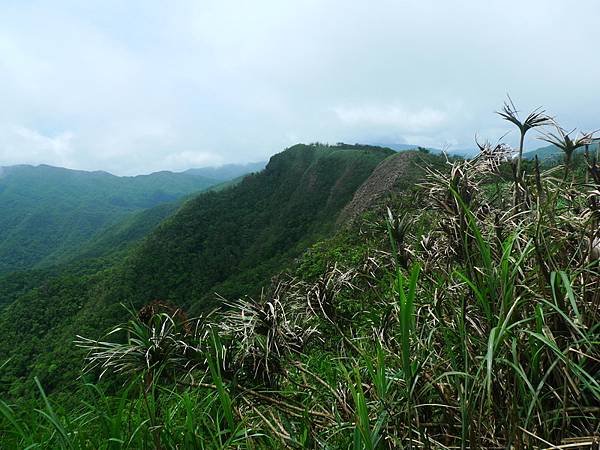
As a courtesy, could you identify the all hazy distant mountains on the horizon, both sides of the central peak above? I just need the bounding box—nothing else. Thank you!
[0,142,596,273]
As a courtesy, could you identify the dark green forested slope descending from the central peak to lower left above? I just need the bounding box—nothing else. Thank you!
[0,145,408,393]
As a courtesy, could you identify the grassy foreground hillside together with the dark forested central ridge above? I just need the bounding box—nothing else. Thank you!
[0,125,600,450]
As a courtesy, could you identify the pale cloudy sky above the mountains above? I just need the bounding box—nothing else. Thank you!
[0,0,600,175]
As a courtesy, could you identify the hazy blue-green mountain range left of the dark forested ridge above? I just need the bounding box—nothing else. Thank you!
[0,165,220,273]
